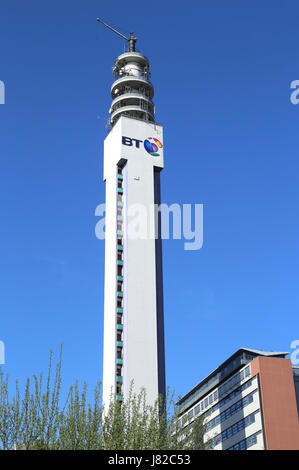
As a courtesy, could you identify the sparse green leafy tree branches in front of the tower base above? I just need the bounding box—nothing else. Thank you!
[0,350,205,450]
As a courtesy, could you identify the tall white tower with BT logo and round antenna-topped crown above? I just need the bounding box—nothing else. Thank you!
[103,20,165,404]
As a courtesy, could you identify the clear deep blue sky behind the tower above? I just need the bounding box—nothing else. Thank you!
[0,0,299,402]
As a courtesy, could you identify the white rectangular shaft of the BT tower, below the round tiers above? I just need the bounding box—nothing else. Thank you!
[103,116,164,404]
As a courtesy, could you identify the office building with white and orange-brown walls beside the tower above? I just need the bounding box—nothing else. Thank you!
[178,348,299,450]
